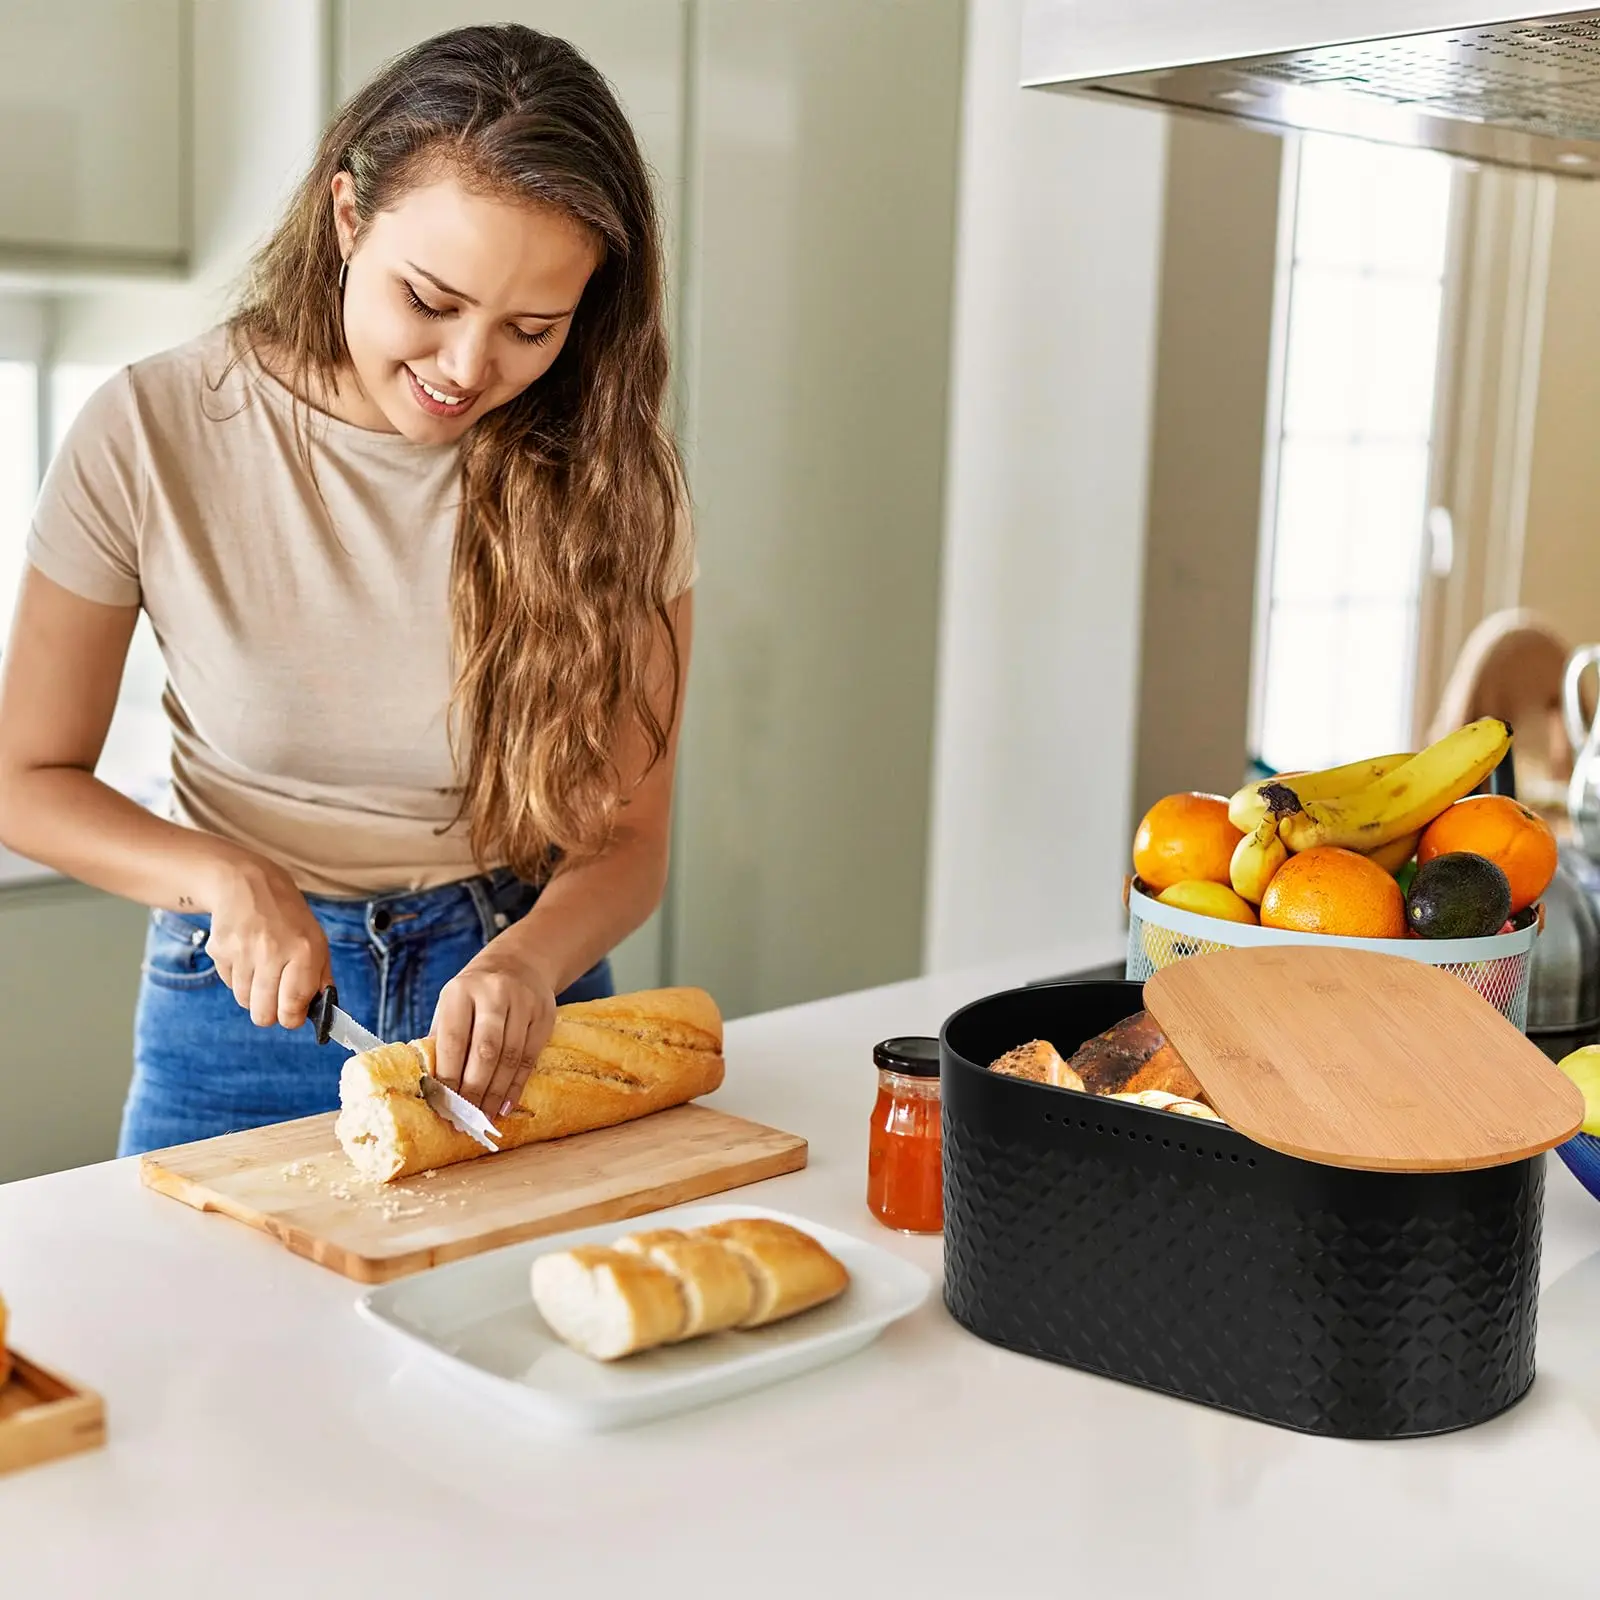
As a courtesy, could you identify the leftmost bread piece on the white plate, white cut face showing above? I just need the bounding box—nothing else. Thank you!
[531,1245,685,1362]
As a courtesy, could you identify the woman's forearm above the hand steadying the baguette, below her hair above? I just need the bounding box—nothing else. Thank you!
[496,834,667,994]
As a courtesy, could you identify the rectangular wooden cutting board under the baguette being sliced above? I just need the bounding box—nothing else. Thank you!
[139,1106,806,1283]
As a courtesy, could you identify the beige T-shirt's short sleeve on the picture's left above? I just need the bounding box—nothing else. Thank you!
[27,368,144,605]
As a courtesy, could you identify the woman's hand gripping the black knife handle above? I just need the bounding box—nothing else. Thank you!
[205,856,333,1027]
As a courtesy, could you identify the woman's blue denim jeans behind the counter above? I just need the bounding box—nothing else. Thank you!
[117,870,613,1155]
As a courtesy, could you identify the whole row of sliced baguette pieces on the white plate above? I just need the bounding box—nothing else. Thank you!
[530,1218,850,1362]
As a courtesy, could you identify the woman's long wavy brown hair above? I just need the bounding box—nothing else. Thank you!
[232,24,683,878]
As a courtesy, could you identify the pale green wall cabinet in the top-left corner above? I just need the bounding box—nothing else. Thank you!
[0,0,189,270]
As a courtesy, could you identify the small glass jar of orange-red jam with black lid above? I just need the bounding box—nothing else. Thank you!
[867,1038,944,1234]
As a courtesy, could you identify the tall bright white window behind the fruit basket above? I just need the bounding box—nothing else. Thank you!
[1254,138,1451,770]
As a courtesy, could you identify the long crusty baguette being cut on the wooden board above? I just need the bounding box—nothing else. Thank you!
[334,989,723,1182]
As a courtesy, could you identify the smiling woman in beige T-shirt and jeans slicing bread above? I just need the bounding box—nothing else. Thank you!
[0,27,694,1154]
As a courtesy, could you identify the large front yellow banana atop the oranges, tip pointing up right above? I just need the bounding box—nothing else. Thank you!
[1267,717,1510,856]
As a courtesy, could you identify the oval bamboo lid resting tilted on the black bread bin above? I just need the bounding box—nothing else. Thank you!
[1144,946,1584,1173]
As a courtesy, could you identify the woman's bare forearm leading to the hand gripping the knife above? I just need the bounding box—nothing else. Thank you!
[0,766,256,912]
